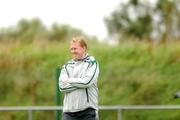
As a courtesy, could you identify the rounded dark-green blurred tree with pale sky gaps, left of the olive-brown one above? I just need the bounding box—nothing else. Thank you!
[105,0,152,39]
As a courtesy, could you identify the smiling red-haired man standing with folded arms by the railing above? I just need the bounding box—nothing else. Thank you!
[59,37,99,120]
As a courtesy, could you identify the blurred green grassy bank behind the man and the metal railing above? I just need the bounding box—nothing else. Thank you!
[0,42,180,120]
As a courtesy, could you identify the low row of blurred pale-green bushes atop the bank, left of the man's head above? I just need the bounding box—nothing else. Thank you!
[0,18,93,43]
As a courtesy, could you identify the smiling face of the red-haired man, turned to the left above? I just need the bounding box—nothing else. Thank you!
[70,42,86,60]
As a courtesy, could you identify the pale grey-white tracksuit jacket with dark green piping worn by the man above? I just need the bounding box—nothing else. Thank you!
[59,54,99,112]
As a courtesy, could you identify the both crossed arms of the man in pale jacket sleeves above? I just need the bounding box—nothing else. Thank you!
[59,62,99,92]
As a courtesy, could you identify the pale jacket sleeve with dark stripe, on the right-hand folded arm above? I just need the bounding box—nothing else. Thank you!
[69,61,99,88]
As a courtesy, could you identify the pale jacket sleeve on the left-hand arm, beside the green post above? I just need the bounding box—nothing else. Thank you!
[59,66,77,92]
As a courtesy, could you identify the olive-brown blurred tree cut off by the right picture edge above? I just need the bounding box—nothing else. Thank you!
[154,0,180,42]
